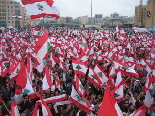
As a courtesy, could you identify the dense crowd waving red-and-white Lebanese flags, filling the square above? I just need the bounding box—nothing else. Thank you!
[0,27,155,116]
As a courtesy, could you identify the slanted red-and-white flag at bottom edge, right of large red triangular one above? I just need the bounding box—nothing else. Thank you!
[127,105,146,116]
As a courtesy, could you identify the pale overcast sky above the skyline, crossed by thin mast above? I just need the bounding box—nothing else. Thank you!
[16,0,147,18]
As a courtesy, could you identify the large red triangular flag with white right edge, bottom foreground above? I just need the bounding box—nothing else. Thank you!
[98,85,123,116]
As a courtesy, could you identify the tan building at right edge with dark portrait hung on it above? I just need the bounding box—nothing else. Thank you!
[145,0,155,27]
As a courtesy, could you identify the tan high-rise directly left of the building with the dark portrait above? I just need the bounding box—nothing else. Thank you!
[134,5,147,27]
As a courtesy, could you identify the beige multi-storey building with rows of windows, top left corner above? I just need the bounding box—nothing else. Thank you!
[0,0,26,27]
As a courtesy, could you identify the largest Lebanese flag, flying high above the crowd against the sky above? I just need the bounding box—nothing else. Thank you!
[22,0,60,19]
